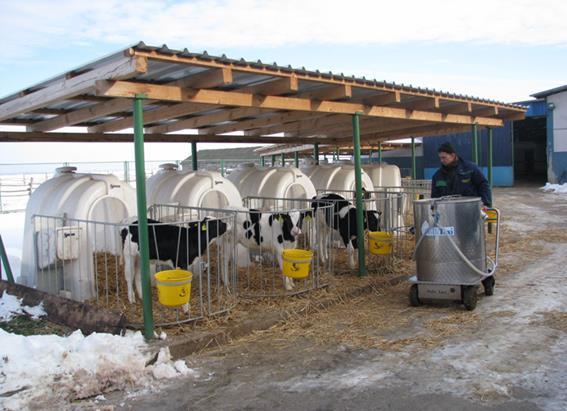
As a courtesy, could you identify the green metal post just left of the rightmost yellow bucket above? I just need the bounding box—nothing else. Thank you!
[352,113,366,277]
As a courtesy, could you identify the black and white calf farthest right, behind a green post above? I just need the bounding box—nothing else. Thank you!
[311,193,382,269]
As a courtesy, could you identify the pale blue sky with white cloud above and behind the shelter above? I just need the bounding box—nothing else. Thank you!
[0,0,567,163]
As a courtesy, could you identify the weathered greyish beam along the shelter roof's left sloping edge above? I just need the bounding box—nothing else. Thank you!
[0,57,147,121]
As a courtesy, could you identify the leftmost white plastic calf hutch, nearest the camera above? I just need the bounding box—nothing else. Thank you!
[21,167,136,301]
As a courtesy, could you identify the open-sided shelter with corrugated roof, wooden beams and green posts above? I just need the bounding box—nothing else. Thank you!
[0,42,525,338]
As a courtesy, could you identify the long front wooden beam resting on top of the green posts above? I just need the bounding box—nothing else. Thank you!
[96,80,503,127]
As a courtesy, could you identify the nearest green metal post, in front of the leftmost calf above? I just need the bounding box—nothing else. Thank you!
[134,95,154,340]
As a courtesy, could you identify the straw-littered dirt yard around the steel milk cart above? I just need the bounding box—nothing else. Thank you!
[91,187,567,410]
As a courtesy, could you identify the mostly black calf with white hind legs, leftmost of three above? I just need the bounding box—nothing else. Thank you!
[120,218,227,303]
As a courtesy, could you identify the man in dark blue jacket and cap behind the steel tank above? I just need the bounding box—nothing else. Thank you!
[431,143,492,207]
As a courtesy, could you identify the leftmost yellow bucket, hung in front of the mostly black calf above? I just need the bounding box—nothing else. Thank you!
[154,270,193,307]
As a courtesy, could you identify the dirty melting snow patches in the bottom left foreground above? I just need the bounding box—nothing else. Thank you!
[0,293,197,410]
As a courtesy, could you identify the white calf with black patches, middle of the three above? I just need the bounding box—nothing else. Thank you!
[236,209,311,290]
